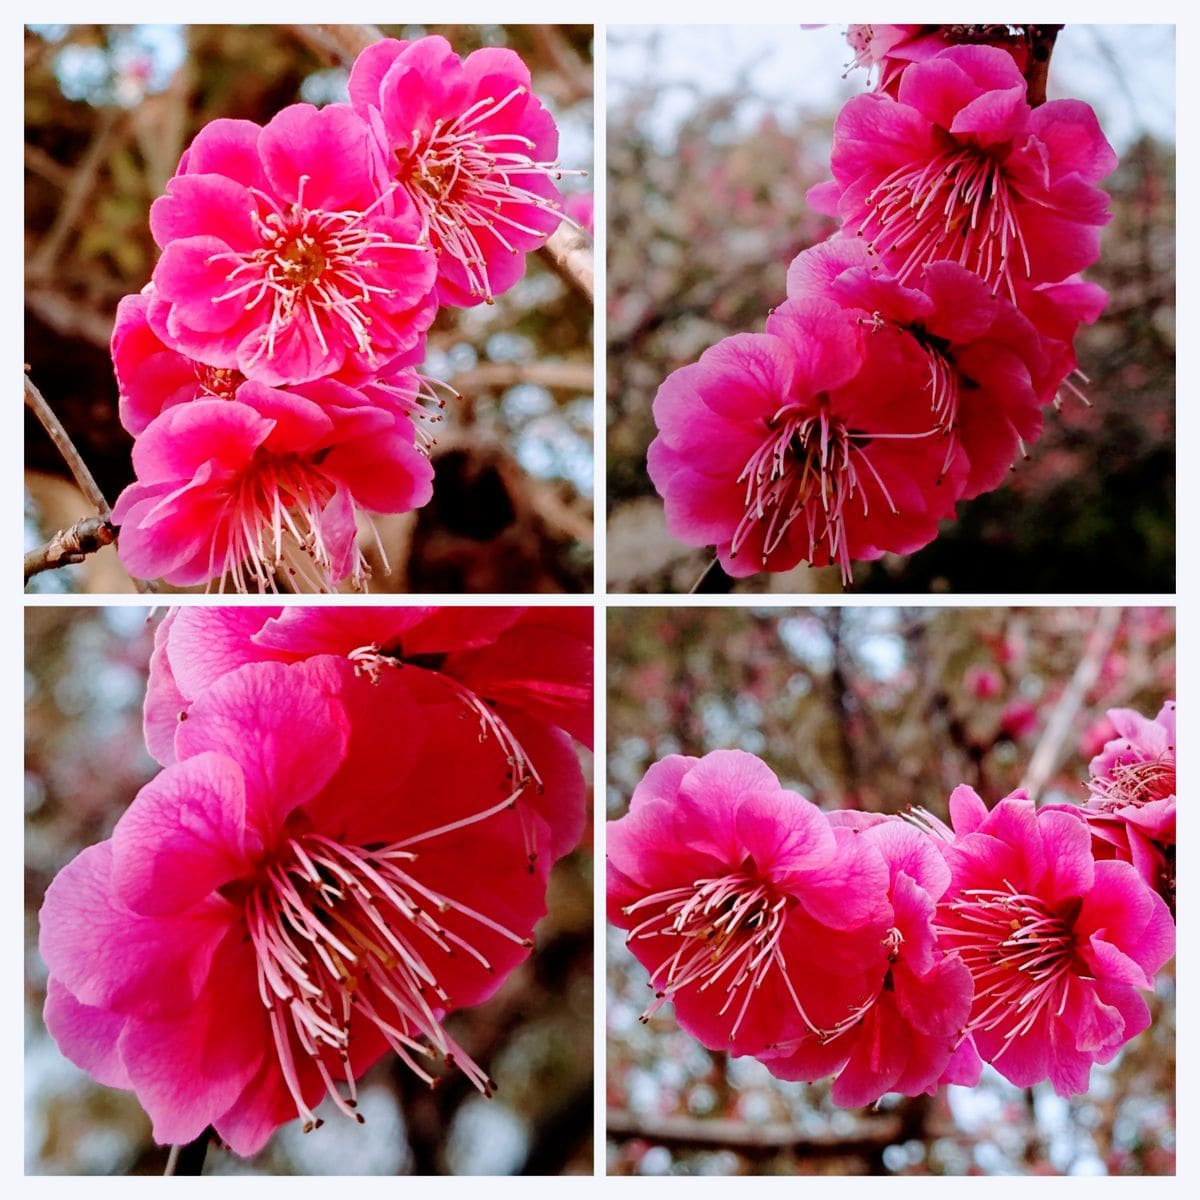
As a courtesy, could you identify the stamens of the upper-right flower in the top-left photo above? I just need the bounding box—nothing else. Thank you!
[395,86,563,302]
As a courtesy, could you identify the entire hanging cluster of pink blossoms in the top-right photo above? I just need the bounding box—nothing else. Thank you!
[648,25,1116,582]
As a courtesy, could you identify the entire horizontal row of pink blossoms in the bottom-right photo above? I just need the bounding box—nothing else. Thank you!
[607,703,1175,1106]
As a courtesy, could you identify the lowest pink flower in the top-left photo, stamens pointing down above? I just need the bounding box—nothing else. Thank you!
[113,380,433,592]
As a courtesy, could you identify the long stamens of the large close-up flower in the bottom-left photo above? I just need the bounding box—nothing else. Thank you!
[244,811,533,1133]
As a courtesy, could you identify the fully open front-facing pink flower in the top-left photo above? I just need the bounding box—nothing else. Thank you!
[149,104,437,384]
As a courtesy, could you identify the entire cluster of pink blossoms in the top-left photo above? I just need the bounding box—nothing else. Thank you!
[112,36,563,592]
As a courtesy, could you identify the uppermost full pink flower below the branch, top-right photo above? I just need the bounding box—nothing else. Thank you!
[809,46,1116,300]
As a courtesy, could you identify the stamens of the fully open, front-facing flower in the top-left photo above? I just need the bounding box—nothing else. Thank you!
[210,175,412,362]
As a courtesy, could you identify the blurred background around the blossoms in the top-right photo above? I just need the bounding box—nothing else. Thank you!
[606,25,1175,593]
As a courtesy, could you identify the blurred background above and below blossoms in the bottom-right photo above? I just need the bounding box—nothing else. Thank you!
[607,607,1175,1175]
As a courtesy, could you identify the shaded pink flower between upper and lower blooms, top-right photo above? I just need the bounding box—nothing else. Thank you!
[787,236,1058,499]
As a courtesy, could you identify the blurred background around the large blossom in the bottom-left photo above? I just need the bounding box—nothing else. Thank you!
[24,606,593,1175]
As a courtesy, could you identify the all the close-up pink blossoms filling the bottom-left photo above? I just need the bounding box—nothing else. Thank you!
[40,607,592,1154]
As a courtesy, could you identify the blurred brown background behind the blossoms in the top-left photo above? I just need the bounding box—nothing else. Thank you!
[25,25,593,592]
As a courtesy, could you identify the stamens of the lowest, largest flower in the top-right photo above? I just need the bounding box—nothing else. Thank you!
[730,404,896,582]
